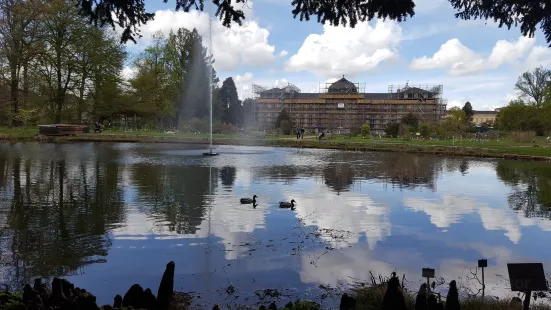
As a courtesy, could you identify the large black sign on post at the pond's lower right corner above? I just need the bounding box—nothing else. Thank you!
[507,263,548,310]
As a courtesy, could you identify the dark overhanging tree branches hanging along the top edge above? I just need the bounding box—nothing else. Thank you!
[74,0,551,42]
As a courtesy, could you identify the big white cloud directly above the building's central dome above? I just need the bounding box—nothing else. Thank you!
[285,20,402,78]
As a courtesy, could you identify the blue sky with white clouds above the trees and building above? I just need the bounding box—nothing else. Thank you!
[124,0,551,110]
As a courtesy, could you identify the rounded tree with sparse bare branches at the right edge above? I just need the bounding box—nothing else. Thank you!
[515,67,551,107]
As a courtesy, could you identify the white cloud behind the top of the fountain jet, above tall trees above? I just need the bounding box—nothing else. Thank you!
[129,8,276,72]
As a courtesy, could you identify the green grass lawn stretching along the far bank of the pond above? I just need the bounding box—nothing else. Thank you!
[0,127,551,157]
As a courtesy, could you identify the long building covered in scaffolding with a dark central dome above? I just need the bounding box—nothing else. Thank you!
[252,76,446,133]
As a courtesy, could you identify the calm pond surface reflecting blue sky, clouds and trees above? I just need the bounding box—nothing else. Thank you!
[0,143,551,304]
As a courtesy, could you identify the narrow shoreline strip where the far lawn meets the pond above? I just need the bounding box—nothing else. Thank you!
[0,133,551,161]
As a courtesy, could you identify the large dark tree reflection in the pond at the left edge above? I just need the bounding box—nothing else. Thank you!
[0,146,123,288]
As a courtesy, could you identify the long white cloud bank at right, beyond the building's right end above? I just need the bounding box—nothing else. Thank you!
[410,36,551,75]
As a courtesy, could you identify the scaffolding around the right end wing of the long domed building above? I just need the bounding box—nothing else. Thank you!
[386,82,446,121]
